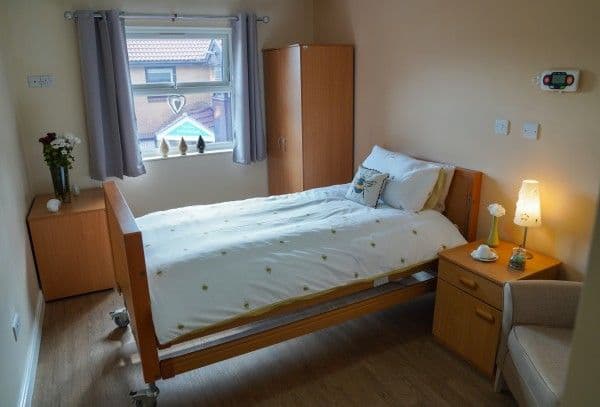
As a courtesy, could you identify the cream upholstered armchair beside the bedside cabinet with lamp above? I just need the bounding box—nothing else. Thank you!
[495,280,581,406]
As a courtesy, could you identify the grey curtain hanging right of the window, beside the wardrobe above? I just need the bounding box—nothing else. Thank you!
[232,13,267,164]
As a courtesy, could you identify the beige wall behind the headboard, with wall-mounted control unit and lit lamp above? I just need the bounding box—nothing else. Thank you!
[314,0,600,279]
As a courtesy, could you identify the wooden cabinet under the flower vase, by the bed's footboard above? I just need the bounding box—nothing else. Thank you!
[27,189,114,301]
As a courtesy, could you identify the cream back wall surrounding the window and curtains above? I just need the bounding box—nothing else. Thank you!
[5,0,313,215]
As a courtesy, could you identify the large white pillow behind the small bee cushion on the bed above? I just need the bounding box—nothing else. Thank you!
[362,146,446,211]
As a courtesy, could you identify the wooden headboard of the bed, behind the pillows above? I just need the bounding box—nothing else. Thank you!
[444,167,483,242]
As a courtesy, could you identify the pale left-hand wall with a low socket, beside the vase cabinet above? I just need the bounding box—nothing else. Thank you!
[0,28,42,406]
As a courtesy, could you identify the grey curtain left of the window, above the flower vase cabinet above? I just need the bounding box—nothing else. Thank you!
[76,10,146,180]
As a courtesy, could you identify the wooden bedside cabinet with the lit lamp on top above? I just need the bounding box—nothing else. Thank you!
[433,241,560,378]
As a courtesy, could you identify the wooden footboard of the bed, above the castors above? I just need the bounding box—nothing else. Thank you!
[104,181,161,383]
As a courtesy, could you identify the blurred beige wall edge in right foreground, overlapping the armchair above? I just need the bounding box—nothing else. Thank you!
[562,198,600,407]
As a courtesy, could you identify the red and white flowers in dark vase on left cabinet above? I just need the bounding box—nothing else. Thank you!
[38,133,81,202]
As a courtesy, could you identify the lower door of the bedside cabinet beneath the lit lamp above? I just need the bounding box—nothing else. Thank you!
[433,280,502,377]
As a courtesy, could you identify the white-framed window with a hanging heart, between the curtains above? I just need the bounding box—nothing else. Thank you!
[126,27,233,158]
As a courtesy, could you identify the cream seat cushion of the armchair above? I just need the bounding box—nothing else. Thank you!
[508,325,572,406]
